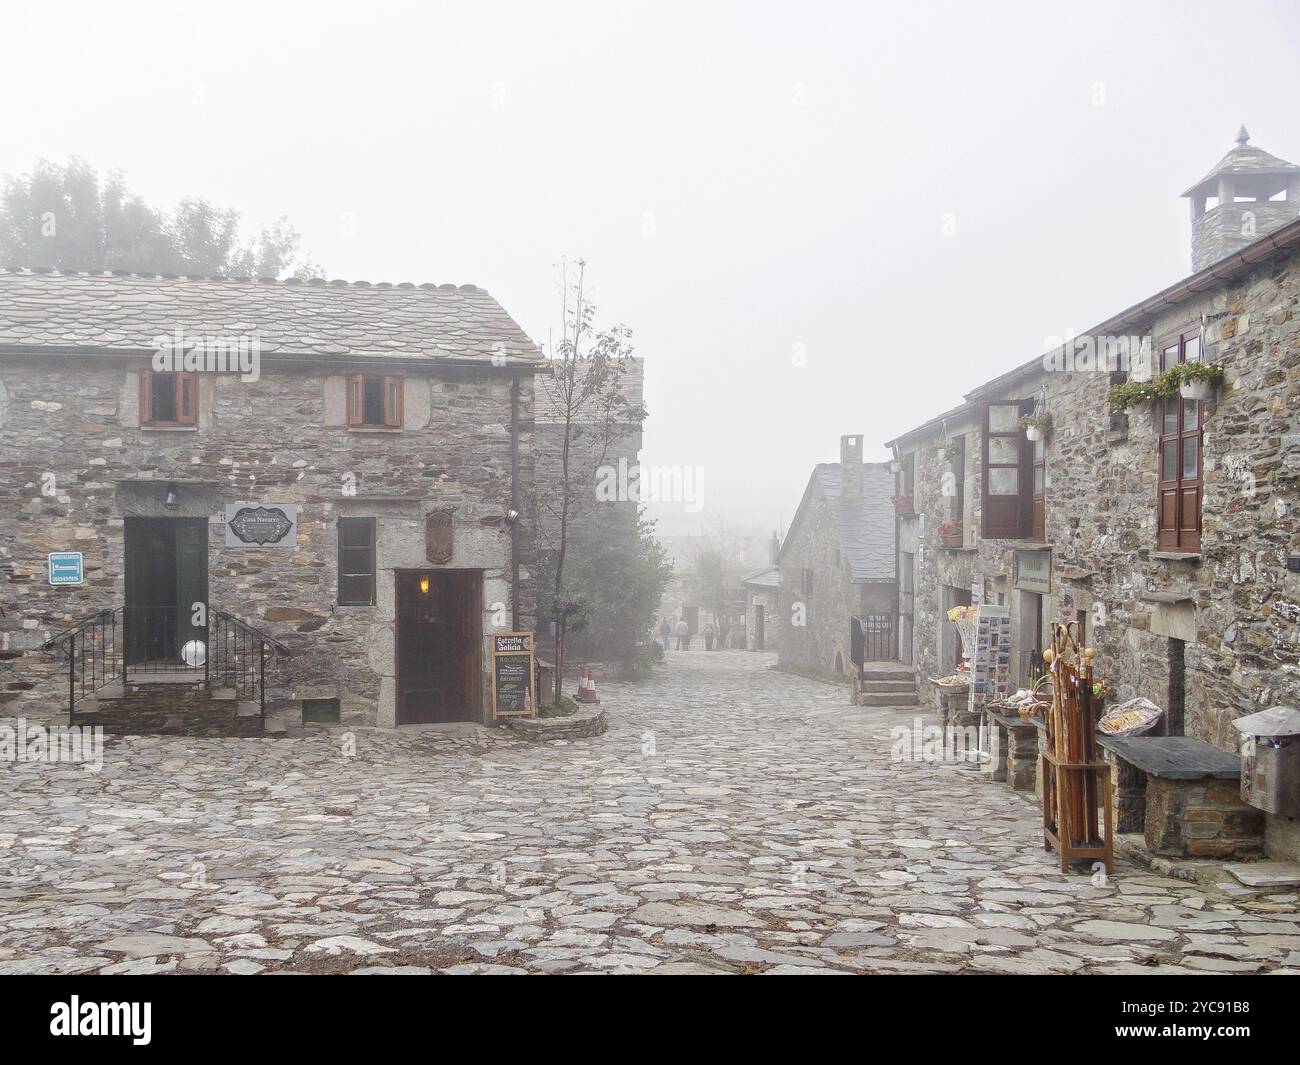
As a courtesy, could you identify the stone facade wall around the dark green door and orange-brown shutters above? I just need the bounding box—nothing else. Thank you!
[0,356,534,724]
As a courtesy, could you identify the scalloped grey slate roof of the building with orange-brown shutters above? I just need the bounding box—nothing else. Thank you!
[0,269,543,364]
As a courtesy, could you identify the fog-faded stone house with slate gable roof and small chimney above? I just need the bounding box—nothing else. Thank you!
[776,436,898,677]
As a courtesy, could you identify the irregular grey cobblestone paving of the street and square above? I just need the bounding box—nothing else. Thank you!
[0,651,1300,973]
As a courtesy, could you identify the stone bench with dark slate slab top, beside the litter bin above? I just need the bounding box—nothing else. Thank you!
[1097,736,1264,858]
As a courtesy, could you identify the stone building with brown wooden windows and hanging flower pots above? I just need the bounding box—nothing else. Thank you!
[889,131,1300,856]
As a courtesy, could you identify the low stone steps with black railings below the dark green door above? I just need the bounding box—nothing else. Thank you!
[73,677,264,736]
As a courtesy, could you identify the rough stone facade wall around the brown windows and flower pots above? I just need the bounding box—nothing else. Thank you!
[900,239,1300,858]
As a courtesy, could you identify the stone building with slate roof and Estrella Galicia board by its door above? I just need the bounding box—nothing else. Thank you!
[0,270,545,726]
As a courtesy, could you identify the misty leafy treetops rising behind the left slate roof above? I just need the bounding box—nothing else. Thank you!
[0,159,321,277]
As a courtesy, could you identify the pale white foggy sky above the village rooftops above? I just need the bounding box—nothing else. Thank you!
[0,1,1300,532]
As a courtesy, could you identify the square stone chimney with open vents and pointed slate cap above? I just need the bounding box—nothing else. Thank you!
[1183,126,1300,270]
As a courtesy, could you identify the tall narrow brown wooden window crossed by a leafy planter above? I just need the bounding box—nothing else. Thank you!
[1156,328,1204,553]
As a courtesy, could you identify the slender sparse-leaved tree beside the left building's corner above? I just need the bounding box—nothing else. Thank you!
[538,259,645,706]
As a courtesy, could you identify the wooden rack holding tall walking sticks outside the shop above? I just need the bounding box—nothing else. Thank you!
[1039,623,1115,873]
